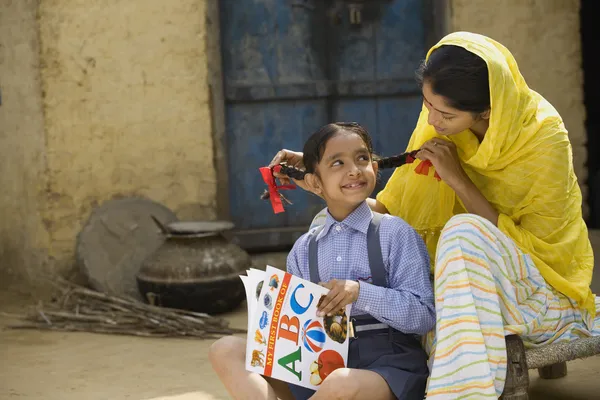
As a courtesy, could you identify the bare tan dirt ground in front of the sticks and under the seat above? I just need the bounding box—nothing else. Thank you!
[0,241,600,400]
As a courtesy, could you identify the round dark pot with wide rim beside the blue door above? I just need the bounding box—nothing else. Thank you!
[136,218,251,314]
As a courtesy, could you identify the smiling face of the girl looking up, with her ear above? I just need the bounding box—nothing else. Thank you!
[309,132,377,218]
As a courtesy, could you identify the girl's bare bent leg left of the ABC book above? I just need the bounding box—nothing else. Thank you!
[208,336,294,400]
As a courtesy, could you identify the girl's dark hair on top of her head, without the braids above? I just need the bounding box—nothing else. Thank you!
[302,122,373,174]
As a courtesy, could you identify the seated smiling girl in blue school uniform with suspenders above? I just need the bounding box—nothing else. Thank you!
[210,123,435,400]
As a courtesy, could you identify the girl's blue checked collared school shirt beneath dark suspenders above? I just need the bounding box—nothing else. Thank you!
[287,201,435,335]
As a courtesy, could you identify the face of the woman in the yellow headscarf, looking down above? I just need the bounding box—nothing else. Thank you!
[423,81,489,136]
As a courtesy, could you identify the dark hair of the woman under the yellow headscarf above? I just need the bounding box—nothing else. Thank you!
[416,45,490,114]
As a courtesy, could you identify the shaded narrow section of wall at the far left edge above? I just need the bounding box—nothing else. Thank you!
[0,0,49,287]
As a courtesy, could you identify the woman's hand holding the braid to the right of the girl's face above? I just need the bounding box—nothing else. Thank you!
[417,138,470,189]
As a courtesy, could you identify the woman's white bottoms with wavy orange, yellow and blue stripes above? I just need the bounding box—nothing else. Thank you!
[427,214,600,400]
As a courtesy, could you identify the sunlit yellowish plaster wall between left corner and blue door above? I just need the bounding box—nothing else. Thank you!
[39,0,216,280]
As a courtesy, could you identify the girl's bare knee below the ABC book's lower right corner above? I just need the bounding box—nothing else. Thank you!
[310,368,396,400]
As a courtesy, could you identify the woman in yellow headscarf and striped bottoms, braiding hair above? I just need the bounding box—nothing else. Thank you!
[271,32,600,399]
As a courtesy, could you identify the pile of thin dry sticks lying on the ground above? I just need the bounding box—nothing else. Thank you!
[2,280,246,339]
